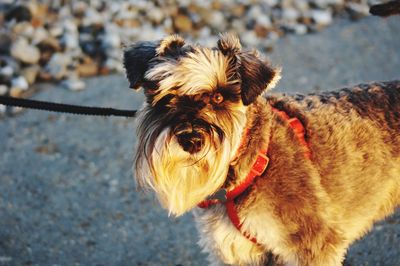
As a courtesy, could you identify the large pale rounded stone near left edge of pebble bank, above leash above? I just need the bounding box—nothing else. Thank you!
[11,37,40,64]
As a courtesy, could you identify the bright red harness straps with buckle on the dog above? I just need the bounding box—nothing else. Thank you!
[198,107,311,243]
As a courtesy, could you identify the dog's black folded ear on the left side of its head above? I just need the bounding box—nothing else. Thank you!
[124,42,159,89]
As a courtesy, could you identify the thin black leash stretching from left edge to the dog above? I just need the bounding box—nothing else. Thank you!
[0,96,136,117]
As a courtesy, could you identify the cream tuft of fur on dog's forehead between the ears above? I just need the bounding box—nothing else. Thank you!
[146,47,237,101]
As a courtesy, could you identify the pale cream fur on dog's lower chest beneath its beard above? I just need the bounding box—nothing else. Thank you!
[194,204,285,265]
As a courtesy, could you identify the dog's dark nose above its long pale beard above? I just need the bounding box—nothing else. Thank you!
[174,123,205,154]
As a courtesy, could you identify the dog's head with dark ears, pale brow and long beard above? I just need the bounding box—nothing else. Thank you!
[124,34,280,215]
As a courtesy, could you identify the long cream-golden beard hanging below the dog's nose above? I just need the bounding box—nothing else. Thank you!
[135,105,246,216]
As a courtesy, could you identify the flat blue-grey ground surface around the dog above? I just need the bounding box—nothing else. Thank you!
[0,17,400,265]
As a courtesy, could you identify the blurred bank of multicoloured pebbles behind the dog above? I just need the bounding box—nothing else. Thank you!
[0,0,376,115]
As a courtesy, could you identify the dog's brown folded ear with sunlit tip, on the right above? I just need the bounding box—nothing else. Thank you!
[239,52,281,105]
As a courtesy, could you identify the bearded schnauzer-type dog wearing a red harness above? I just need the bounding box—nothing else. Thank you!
[124,34,400,266]
